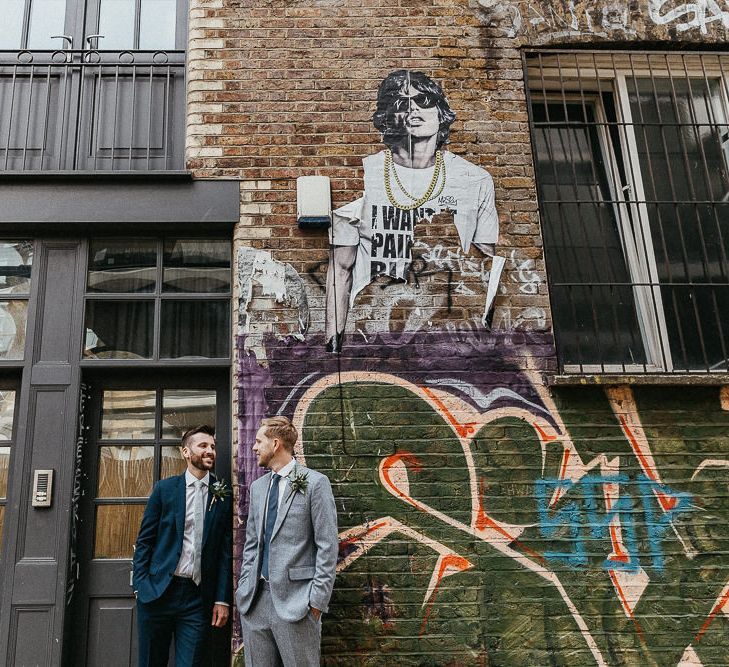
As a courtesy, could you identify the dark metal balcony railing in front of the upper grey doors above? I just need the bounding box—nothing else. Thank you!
[0,51,185,172]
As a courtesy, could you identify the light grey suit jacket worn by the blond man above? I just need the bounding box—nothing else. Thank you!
[235,463,339,621]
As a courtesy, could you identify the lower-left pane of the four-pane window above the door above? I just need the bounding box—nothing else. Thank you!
[84,301,154,359]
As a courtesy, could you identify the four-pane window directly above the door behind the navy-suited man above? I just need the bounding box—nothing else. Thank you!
[84,239,231,361]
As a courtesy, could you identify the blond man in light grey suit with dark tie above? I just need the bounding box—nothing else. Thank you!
[235,417,339,667]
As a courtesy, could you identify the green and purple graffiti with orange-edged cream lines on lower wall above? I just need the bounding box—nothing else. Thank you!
[233,332,729,665]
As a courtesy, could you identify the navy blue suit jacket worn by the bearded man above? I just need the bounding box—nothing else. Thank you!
[133,473,233,606]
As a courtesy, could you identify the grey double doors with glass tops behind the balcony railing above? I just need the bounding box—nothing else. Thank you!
[0,0,187,171]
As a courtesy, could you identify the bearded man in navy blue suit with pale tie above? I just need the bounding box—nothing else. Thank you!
[133,426,232,667]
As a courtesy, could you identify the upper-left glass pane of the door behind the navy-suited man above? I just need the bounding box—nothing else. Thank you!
[101,390,156,440]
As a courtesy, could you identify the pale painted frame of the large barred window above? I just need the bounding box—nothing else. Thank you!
[523,49,729,375]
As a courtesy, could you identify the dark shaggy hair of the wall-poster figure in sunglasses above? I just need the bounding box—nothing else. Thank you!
[372,69,456,148]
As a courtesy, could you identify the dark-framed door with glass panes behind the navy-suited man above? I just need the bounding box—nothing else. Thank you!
[74,376,232,665]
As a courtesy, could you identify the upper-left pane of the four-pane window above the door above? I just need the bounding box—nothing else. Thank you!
[88,240,157,293]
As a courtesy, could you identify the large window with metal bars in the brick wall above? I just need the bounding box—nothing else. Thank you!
[525,51,729,373]
